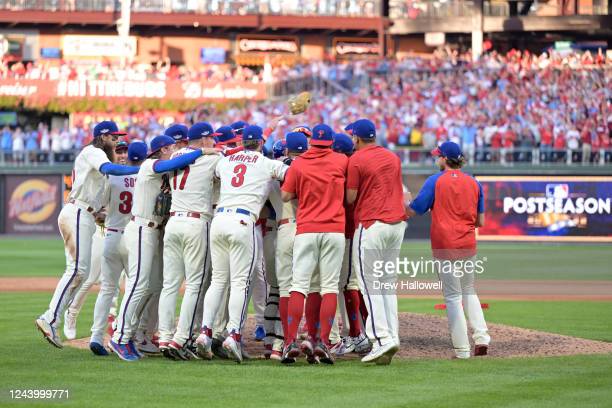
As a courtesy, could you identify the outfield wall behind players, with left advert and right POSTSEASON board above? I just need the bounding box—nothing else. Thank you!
[0,166,612,242]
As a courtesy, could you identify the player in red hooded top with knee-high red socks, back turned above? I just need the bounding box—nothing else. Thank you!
[282,124,348,364]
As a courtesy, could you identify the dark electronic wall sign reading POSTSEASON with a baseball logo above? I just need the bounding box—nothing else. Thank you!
[477,176,612,242]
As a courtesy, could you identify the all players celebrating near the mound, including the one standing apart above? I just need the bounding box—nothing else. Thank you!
[36,115,490,365]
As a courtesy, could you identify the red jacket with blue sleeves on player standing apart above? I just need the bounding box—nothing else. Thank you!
[410,169,484,259]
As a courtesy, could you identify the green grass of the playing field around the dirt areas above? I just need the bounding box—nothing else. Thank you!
[0,239,612,408]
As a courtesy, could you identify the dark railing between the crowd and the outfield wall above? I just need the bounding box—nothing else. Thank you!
[0,146,612,168]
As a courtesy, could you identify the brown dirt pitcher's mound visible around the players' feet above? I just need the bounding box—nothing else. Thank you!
[65,313,612,359]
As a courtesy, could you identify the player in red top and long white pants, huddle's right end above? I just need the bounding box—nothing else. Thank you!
[346,119,406,364]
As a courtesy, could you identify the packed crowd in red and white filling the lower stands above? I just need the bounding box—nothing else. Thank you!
[0,51,612,163]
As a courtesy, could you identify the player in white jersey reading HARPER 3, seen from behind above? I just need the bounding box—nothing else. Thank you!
[196,126,287,362]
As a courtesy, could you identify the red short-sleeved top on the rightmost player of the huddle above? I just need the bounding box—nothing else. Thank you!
[346,145,406,228]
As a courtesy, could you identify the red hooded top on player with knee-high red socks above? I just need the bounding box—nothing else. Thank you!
[281,146,348,234]
